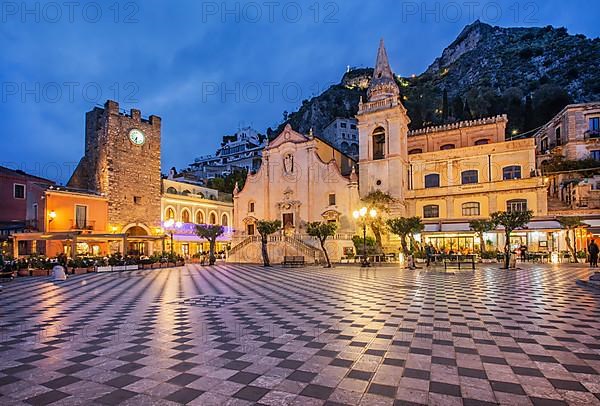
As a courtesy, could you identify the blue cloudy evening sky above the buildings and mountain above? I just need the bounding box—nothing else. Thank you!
[0,0,600,182]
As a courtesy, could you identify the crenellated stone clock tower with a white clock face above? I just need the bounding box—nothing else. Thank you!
[68,100,161,236]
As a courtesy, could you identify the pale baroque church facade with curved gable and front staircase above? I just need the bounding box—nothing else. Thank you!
[228,125,359,262]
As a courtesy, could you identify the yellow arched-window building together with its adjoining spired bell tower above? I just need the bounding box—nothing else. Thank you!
[357,38,559,251]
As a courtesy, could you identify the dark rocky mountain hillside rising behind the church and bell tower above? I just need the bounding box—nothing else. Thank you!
[268,21,600,140]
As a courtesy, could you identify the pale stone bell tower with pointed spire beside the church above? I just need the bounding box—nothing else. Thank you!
[356,39,410,215]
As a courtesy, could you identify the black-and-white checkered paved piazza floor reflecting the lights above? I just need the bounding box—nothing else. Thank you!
[0,265,600,406]
